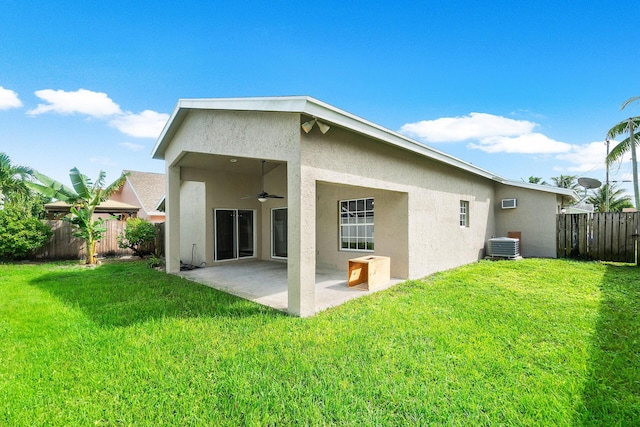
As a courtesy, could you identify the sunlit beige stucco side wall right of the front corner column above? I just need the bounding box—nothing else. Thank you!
[301,123,495,278]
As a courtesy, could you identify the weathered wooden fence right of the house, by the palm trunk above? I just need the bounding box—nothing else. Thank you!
[557,212,640,265]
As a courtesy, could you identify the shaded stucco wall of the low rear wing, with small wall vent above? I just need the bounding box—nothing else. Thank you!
[492,184,561,258]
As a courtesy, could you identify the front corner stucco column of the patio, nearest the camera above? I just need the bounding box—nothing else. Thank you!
[287,161,316,317]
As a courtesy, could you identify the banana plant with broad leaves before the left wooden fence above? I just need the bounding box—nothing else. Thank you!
[27,168,127,264]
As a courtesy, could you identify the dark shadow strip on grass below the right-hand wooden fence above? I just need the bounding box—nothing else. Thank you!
[578,265,640,426]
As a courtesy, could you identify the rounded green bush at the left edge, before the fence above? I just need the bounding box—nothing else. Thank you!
[0,206,53,260]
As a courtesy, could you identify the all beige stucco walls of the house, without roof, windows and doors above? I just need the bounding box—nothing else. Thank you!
[156,99,559,316]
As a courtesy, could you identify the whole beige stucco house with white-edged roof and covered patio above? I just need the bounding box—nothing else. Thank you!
[152,96,575,316]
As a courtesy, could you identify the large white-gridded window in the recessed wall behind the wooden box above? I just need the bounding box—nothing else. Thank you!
[339,197,373,252]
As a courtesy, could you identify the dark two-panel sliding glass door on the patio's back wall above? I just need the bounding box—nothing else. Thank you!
[214,209,255,261]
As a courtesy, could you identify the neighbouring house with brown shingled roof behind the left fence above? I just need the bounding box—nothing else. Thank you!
[110,170,165,223]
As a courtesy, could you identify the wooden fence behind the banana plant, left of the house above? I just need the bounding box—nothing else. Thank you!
[34,220,164,260]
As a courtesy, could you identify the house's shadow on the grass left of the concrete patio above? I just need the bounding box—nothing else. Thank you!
[31,262,284,327]
